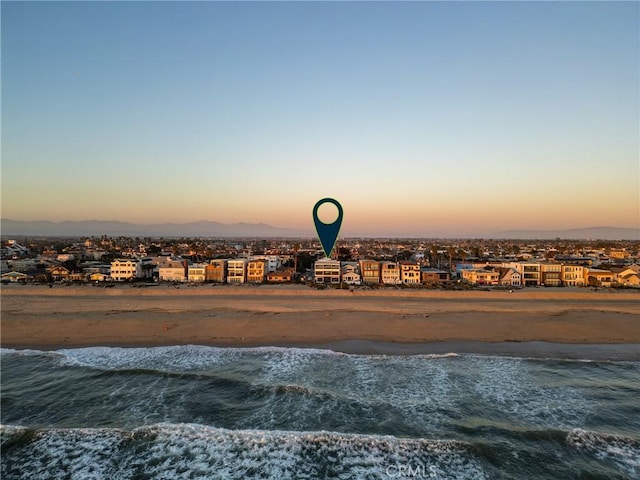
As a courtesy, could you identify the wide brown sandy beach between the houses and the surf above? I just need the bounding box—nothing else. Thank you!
[1,285,640,348]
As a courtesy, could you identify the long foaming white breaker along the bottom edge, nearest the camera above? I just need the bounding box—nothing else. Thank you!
[0,424,487,480]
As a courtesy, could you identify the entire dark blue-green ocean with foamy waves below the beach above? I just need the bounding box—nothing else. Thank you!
[0,346,640,480]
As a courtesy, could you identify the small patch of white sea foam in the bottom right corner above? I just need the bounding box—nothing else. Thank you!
[567,428,640,478]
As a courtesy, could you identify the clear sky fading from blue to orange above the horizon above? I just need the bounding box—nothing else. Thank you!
[0,1,640,236]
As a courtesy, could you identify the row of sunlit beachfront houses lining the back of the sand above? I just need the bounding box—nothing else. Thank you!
[2,255,640,287]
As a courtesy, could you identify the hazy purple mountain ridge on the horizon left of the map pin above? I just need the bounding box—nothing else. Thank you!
[0,218,312,238]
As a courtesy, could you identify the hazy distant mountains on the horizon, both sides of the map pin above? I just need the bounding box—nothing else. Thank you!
[0,219,640,240]
